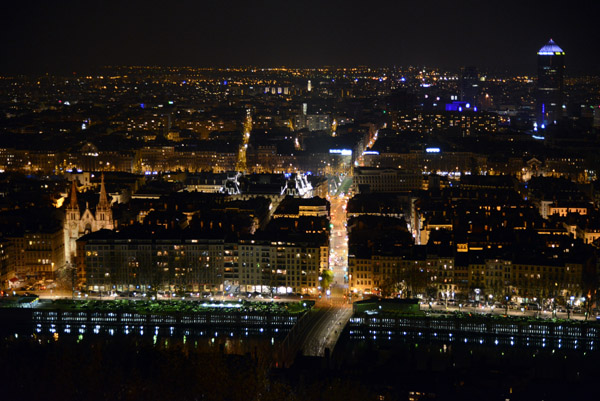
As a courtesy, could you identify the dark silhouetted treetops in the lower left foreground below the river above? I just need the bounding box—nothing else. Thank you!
[0,338,375,401]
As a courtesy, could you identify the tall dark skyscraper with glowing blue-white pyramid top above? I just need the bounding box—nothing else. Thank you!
[535,39,565,129]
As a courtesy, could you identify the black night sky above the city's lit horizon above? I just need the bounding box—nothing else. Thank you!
[0,0,600,73]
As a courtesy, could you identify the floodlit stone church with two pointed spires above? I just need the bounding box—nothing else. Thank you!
[64,174,114,265]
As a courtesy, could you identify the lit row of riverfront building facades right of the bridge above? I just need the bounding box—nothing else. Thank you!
[348,255,583,301]
